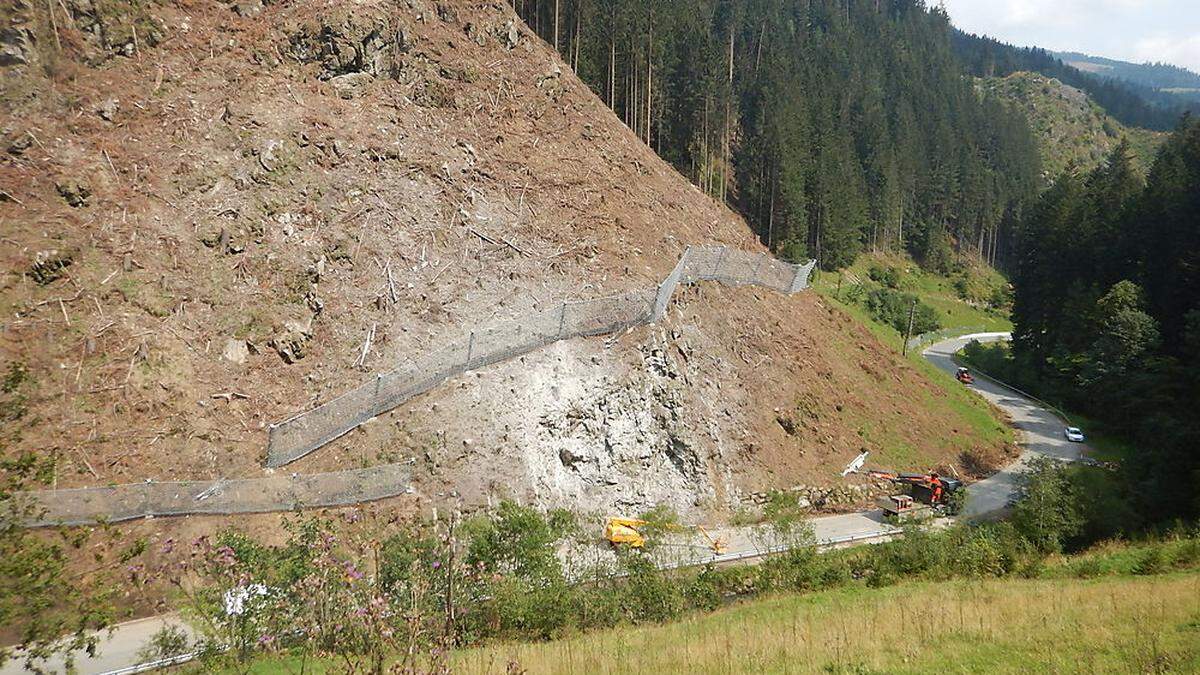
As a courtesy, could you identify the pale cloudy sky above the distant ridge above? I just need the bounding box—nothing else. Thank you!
[945,0,1200,72]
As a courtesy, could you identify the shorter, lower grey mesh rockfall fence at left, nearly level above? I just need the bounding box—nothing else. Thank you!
[19,464,412,527]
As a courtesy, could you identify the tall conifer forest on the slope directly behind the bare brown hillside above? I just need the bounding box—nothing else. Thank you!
[515,0,1039,269]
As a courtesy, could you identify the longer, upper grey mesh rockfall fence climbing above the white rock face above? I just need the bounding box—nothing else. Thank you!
[266,246,816,467]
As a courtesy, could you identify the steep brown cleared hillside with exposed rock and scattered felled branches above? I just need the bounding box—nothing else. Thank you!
[0,0,1012,521]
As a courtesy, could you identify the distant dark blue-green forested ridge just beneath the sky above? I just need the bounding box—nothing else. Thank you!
[954,30,1200,131]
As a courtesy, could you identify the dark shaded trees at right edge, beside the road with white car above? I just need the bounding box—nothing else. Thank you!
[1013,118,1200,521]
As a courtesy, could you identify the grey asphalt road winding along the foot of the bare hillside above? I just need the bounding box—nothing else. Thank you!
[0,333,1086,675]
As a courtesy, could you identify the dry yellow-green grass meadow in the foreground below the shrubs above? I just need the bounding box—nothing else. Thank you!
[454,572,1200,674]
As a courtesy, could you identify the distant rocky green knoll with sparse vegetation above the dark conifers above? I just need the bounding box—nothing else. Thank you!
[979,72,1165,179]
